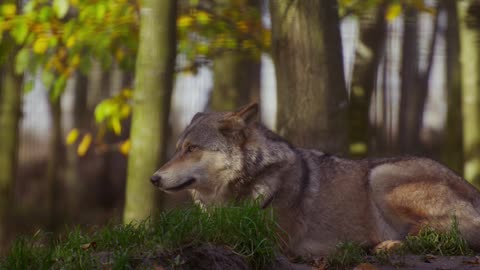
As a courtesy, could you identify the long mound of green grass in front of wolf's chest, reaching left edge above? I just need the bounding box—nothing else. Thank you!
[0,202,278,269]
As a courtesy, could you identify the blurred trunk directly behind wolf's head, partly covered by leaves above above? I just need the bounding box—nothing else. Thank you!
[210,0,261,111]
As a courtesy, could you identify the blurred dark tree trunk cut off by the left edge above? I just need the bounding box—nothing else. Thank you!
[0,0,22,247]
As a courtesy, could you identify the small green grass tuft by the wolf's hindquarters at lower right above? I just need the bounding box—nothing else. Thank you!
[404,217,474,256]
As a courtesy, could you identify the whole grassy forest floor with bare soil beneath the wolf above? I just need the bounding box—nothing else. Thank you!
[0,202,480,270]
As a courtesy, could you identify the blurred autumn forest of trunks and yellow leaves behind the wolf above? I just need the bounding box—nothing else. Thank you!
[0,0,480,253]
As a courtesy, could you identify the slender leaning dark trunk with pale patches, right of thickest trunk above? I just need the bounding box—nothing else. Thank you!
[348,5,387,158]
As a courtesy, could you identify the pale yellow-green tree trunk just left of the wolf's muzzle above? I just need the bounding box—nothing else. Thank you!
[123,0,176,223]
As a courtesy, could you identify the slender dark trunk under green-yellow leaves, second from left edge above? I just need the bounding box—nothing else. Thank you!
[45,97,64,231]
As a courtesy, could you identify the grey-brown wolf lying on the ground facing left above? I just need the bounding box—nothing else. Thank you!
[151,103,480,257]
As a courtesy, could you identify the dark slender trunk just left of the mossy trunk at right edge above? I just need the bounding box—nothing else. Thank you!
[442,0,463,175]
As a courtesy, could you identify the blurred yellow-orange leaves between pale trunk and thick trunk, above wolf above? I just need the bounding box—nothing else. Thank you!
[177,0,271,71]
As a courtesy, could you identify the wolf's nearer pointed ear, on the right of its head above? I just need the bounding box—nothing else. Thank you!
[219,102,258,134]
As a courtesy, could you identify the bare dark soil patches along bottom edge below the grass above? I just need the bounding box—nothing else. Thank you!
[122,245,480,270]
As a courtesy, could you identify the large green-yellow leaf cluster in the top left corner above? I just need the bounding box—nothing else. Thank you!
[0,0,139,99]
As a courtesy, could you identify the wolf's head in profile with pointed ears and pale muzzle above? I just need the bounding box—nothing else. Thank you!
[151,103,258,193]
